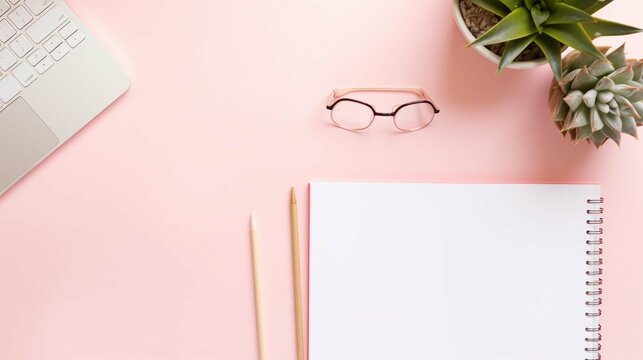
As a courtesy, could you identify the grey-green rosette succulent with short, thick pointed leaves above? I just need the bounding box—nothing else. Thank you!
[549,45,643,148]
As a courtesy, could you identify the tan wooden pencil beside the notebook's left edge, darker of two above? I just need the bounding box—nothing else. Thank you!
[290,187,304,360]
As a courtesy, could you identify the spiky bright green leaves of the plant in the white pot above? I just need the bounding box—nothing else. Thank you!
[469,0,641,79]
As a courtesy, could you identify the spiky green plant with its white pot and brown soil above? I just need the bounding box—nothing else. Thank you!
[453,0,641,80]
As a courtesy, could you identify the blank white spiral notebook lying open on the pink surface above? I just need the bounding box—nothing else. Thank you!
[308,183,603,360]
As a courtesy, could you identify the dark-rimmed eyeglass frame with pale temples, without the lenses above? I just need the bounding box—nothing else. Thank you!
[326,88,440,132]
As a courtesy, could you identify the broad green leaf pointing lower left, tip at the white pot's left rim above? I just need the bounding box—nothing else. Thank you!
[468,8,537,46]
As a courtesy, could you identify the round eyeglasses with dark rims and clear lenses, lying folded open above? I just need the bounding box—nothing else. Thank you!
[326,88,440,132]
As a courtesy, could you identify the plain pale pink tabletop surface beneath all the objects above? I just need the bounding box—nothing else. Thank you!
[0,0,643,360]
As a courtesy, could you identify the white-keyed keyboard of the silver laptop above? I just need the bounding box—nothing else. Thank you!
[0,0,85,111]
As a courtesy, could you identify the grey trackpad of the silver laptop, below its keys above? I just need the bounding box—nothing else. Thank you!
[0,98,58,192]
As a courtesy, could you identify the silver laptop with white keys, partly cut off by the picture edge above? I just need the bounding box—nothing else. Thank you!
[0,0,130,196]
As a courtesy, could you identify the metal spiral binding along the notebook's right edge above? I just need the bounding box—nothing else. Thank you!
[585,198,603,360]
